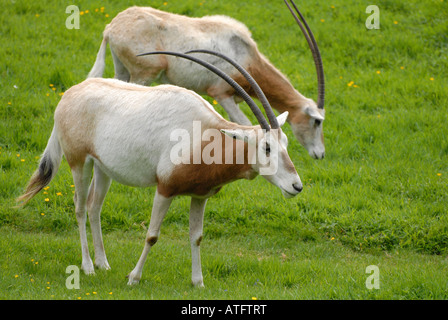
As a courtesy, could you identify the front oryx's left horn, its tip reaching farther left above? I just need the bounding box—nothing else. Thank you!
[137,51,270,131]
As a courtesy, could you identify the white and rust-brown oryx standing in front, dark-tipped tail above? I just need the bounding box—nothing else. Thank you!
[18,54,302,286]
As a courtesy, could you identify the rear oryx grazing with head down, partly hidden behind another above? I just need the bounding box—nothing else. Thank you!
[89,0,325,159]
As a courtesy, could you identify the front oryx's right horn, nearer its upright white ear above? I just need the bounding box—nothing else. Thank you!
[185,49,279,129]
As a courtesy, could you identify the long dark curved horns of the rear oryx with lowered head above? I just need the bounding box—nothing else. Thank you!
[283,0,325,109]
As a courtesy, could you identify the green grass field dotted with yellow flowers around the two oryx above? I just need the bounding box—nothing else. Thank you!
[0,0,448,300]
